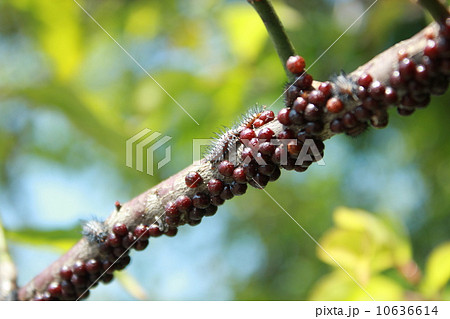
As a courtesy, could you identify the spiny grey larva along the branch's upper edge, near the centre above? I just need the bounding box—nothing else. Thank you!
[204,105,265,164]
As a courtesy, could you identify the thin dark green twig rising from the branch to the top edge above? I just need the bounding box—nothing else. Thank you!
[248,0,295,82]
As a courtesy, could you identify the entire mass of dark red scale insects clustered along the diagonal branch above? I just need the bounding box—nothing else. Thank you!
[34,19,450,300]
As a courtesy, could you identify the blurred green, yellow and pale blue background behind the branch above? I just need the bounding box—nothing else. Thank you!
[0,0,450,300]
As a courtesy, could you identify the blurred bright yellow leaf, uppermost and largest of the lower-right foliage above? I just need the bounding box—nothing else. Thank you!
[317,207,411,281]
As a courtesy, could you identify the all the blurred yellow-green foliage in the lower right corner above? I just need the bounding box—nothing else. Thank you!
[310,207,450,300]
